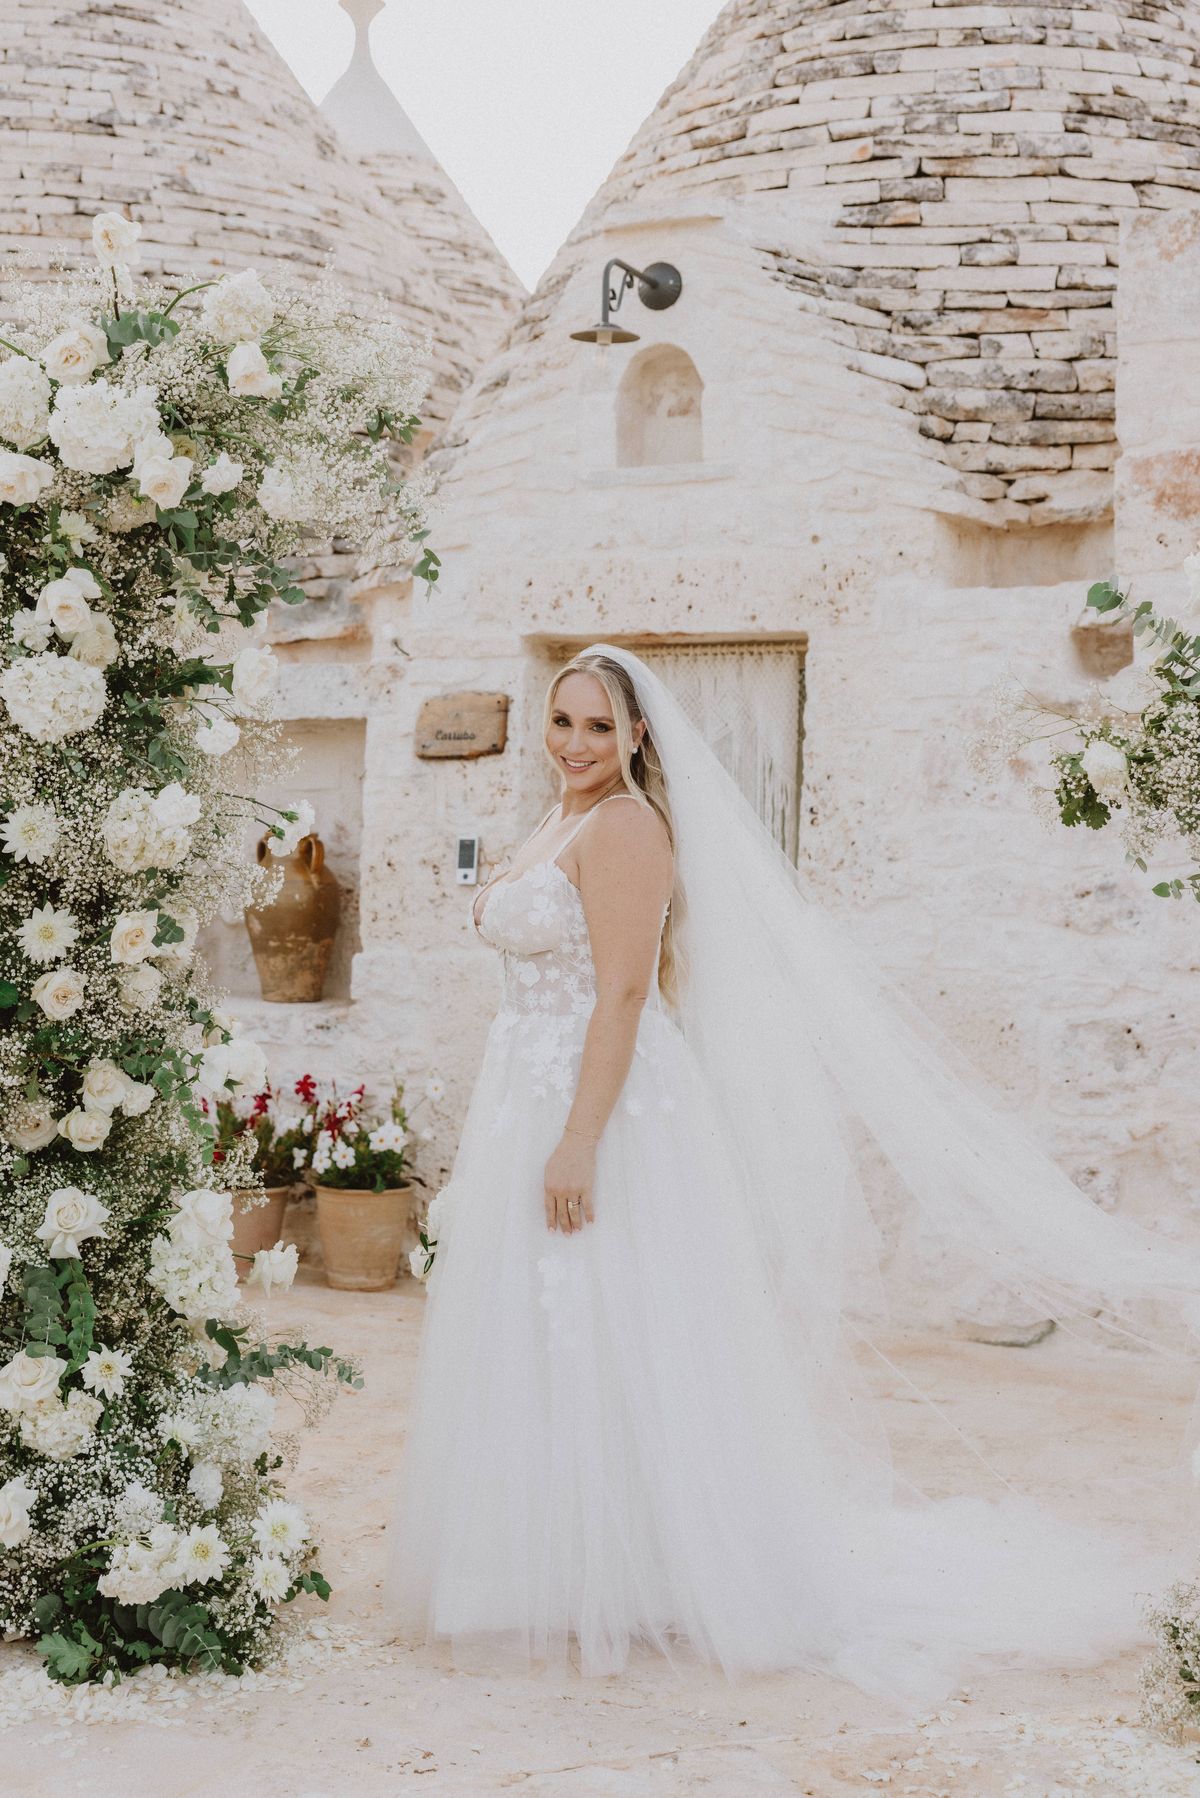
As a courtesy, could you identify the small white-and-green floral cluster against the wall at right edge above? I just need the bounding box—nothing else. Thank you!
[973,552,1200,901]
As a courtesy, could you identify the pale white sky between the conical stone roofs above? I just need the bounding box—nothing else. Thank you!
[246,0,721,286]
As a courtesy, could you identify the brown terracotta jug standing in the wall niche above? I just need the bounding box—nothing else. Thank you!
[245,836,342,1003]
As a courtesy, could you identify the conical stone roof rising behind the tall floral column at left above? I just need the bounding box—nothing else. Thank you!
[0,0,521,431]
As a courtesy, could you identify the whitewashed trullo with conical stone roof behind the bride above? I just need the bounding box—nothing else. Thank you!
[368,0,1200,1323]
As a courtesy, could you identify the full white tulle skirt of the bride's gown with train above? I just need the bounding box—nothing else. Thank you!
[387,1009,1162,1706]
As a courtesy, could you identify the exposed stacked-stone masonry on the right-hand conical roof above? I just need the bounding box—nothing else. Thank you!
[564,0,1200,523]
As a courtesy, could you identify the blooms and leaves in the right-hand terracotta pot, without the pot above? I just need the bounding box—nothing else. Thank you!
[288,1073,446,1192]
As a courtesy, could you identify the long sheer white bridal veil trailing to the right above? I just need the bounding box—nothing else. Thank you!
[588,644,1200,1492]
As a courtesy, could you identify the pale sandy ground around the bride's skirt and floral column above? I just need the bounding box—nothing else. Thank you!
[0,1278,1200,1798]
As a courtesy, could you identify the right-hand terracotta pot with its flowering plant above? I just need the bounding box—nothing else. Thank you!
[295,1075,439,1293]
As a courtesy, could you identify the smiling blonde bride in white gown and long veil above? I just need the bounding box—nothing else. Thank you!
[387,644,1200,1705]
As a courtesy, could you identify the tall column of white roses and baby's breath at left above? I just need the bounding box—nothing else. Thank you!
[0,214,435,1681]
